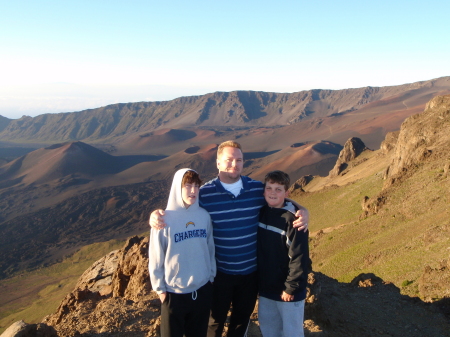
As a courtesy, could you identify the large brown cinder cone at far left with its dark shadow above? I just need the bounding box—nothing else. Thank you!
[0,142,164,225]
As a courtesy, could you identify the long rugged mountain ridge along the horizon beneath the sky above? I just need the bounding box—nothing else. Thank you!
[0,77,450,147]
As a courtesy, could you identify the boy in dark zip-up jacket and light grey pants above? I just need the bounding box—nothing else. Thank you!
[257,171,311,337]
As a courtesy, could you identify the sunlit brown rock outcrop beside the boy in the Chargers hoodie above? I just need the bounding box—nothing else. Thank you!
[44,236,160,336]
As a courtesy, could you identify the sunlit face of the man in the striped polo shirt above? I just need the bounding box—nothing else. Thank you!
[217,147,244,184]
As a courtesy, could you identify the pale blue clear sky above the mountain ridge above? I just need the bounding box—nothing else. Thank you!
[0,0,450,118]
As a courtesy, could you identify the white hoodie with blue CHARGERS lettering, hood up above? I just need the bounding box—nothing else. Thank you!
[148,169,216,294]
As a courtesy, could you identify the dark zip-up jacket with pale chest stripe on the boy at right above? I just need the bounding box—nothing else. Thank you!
[258,203,311,301]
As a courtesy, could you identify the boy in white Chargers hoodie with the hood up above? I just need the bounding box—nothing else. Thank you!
[149,169,216,337]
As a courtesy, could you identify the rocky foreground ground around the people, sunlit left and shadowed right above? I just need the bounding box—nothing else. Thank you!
[2,237,450,337]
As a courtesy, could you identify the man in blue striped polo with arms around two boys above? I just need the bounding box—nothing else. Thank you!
[149,141,309,337]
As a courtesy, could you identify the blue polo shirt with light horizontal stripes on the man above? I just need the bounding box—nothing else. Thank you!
[200,176,265,275]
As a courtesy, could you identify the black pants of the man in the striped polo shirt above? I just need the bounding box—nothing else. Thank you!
[208,272,258,337]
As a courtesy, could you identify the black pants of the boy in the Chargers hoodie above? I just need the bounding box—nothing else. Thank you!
[161,282,213,337]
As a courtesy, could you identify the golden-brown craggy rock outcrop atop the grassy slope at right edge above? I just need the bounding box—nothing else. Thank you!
[356,95,450,219]
